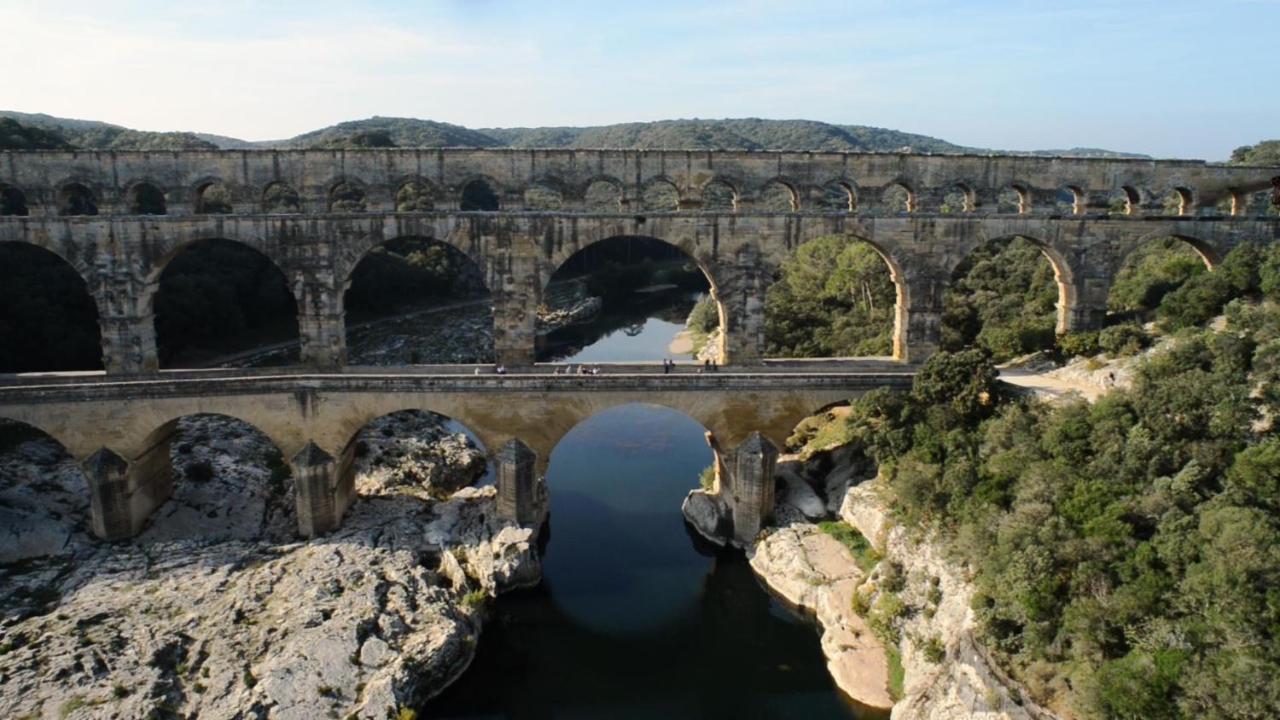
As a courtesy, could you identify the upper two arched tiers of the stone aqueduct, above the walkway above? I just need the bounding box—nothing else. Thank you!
[0,149,1280,374]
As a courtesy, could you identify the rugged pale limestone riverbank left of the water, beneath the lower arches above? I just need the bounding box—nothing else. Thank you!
[0,414,540,719]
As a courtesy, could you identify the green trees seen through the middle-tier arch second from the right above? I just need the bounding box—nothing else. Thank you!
[942,237,1057,360]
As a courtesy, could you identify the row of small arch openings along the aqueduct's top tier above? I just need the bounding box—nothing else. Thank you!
[0,178,1267,217]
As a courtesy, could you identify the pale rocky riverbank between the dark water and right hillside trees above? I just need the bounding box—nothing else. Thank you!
[685,435,1055,720]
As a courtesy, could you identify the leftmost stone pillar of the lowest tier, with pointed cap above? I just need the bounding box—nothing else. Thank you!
[81,438,173,541]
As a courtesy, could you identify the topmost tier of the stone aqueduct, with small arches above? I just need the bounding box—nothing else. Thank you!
[0,149,1280,215]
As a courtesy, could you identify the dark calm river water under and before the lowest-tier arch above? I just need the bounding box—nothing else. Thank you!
[432,405,858,720]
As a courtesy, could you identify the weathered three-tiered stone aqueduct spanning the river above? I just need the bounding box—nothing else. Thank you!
[0,149,1280,538]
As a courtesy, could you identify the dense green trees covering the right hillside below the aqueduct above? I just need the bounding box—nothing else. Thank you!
[797,326,1280,720]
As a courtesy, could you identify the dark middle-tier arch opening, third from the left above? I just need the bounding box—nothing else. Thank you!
[340,236,493,365]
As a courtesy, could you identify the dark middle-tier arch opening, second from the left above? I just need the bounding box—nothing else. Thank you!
[142,237,301,368]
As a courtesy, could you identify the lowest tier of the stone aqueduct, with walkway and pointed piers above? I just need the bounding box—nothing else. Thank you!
[0,369,913,539]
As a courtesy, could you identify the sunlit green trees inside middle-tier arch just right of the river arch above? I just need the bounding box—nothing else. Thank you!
[764,237,896,357]
